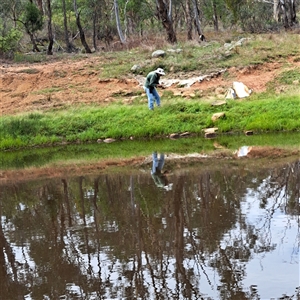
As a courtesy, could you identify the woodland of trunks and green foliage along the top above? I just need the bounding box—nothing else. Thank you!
[0,0,299,58]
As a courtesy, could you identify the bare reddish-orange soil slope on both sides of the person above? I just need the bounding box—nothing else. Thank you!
[0,56,300,115]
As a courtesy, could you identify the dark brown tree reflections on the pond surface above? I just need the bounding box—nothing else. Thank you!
[0,158,300,299]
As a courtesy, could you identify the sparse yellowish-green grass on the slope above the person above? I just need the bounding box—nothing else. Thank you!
[94,33,300,78]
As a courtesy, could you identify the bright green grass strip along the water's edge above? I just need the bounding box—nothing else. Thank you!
[0,95,300,150]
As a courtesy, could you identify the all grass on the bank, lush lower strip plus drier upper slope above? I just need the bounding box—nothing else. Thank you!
[0,33,300,150]
